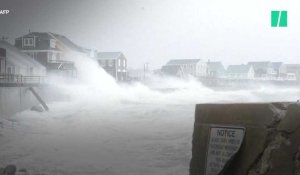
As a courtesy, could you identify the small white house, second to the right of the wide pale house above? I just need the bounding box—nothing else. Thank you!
[227,65,255,79]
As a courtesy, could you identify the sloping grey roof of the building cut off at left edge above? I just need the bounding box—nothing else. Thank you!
[0,40,45,69]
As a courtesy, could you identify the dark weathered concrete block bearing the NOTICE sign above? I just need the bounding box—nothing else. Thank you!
[190,103,300,175]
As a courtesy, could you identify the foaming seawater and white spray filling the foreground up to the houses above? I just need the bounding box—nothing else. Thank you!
[0,54,300,175]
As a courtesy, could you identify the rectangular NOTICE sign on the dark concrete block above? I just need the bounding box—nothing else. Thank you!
[205,126,245,175]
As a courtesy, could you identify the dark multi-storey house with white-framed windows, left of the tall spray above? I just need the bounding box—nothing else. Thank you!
[15,32,86,77]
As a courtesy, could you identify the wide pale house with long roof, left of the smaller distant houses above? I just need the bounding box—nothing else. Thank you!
[162,59,207,77]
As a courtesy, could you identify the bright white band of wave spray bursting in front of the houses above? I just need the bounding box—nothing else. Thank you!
[48,54,300,106]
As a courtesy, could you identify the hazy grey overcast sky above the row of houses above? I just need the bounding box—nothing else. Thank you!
[0,0,300,68]
